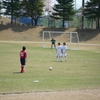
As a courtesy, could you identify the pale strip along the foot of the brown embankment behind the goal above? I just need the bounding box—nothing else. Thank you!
[0,40,100,46]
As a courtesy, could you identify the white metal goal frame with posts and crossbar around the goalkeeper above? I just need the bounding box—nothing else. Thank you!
[42,31,81,50]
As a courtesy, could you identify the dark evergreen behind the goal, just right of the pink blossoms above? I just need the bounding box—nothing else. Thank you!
[51,0,75,27]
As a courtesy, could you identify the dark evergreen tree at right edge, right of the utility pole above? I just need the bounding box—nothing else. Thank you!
[84,0,100,29]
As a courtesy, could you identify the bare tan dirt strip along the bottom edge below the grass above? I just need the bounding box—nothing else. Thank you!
[0,89,100,100]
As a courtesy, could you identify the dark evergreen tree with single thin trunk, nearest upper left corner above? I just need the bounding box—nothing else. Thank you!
[3,0,20,25]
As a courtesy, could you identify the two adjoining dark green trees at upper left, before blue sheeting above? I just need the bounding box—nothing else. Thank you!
[3,0,44,25]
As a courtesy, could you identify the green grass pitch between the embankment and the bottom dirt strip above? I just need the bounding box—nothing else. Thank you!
[0,43,100,94]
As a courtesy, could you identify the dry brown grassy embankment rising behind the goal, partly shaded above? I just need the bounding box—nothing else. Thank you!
[0,25,100,44]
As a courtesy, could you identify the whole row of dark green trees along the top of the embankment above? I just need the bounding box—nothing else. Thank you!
[0,0,100,29]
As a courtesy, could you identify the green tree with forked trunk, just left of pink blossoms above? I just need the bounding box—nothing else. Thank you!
[21,0,44,26]
